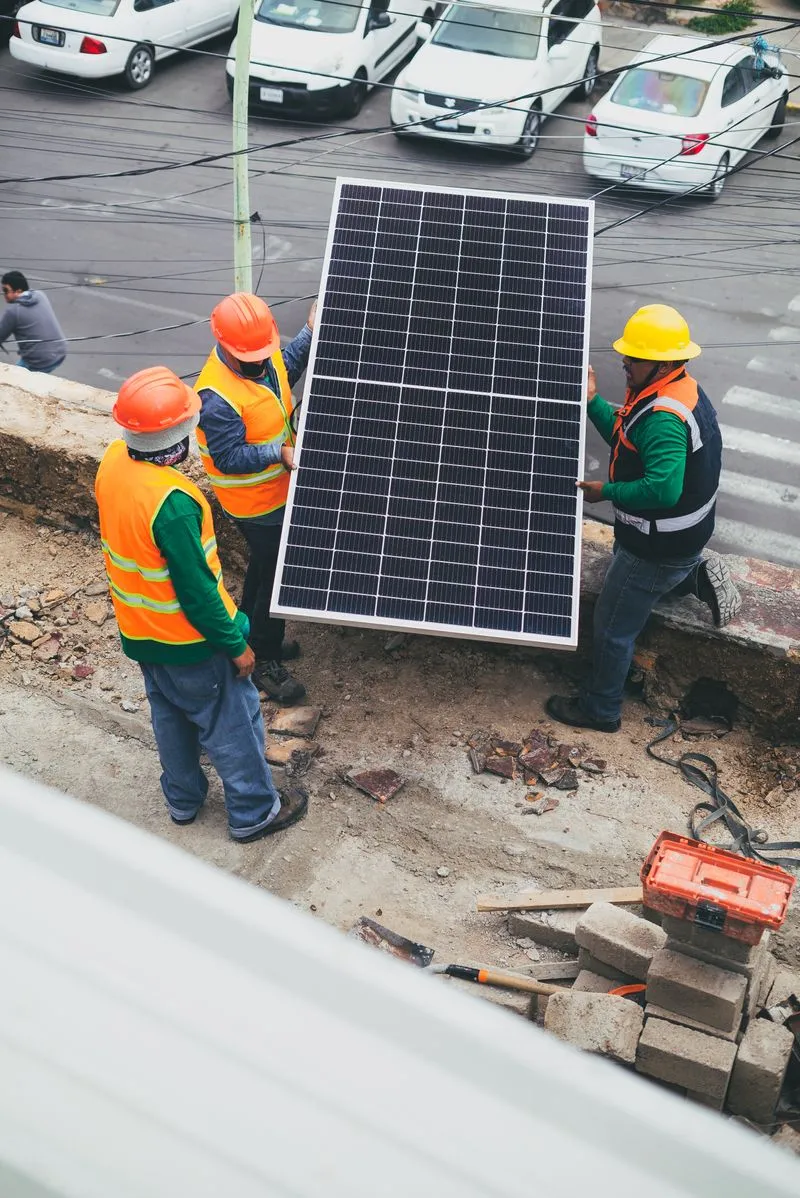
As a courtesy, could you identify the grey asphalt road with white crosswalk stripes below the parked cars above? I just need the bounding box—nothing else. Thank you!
[0,33,800,565]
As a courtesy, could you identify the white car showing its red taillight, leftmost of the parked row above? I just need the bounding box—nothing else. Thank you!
[8,0,238,87]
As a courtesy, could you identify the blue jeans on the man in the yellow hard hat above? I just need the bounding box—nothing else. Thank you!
[581,544,703,721]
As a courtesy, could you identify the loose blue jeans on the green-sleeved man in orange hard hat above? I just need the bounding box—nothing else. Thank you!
[140,653,280,840]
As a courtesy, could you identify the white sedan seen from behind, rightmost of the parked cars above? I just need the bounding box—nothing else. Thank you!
[583,35,788,199]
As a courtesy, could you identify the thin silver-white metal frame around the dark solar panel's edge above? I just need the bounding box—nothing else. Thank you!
[271,176,594,649]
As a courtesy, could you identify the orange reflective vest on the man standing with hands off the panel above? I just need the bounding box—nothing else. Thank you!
[95,441,236,645]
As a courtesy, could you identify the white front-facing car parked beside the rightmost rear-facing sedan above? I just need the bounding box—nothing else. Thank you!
[392,0,601,158]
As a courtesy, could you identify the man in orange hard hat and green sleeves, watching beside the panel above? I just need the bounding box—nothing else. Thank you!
[95,367,308,841]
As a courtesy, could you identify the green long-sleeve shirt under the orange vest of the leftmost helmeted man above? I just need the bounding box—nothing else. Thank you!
[120,491,250,666]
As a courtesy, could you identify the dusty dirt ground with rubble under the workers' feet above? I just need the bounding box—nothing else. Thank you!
[0,514,800,1001]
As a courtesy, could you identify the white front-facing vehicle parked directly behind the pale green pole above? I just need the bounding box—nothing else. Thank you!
[234,0,440,116]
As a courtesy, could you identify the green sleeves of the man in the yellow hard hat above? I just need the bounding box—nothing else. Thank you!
[588,395,686,512]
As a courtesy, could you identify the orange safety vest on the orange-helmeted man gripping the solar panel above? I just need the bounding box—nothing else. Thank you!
[194,347,295,520]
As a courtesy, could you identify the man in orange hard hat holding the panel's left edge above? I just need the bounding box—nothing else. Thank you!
[195,292,316,704]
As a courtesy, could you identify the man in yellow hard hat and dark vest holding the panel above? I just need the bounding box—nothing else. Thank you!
[546,303,741,732]
